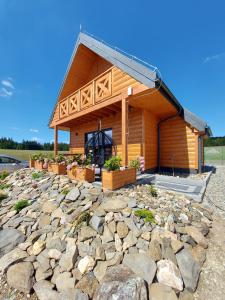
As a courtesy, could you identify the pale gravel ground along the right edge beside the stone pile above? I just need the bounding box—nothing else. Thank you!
[195,167,225,300]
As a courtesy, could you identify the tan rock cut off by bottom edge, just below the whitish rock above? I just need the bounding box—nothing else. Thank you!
[149,283,177,300]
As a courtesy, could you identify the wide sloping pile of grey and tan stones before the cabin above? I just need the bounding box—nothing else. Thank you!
[0,169,212,300]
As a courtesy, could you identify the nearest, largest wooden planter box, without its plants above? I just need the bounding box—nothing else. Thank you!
[102,168,136,190]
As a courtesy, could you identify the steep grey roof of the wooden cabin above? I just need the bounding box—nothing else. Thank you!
[49,32,211,135]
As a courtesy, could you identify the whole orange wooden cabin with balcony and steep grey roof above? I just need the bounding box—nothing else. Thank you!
[49,33,211,172]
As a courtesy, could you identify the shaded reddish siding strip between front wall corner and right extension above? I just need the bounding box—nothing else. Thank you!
[143,110,159,169]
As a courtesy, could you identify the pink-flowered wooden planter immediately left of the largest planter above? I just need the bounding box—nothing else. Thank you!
[67,154,95,182]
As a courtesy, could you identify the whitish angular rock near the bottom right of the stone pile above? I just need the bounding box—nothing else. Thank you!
[157,259,183,291]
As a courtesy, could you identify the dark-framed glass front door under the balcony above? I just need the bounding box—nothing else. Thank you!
[85,128,113,168]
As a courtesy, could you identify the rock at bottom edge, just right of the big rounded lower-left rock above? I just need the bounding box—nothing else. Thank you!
[33,280,62,300]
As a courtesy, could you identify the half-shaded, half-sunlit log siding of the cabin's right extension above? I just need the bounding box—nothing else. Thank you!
[160,117,198,169]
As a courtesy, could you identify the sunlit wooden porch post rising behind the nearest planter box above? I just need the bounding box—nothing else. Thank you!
[121,98,128,167]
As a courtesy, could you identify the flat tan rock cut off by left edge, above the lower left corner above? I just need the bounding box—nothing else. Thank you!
[0,248,28,273]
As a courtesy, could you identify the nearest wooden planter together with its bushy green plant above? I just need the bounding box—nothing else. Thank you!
[102,156,136,190]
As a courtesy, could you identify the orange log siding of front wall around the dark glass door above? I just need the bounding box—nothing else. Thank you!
[70,109,142,161]
